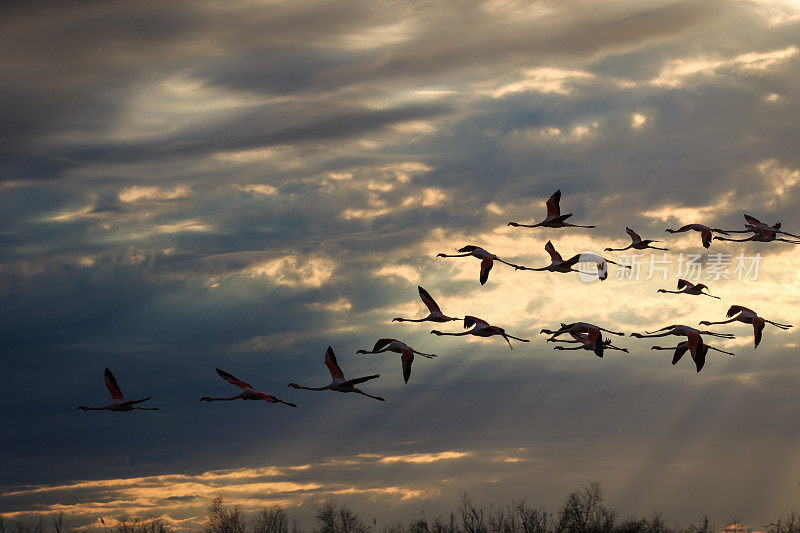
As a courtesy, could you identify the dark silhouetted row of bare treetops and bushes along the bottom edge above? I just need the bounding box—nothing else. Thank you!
[0,482,800,533]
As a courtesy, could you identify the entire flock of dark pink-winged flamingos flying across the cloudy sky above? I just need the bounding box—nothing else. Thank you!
[78,190,800,412]
